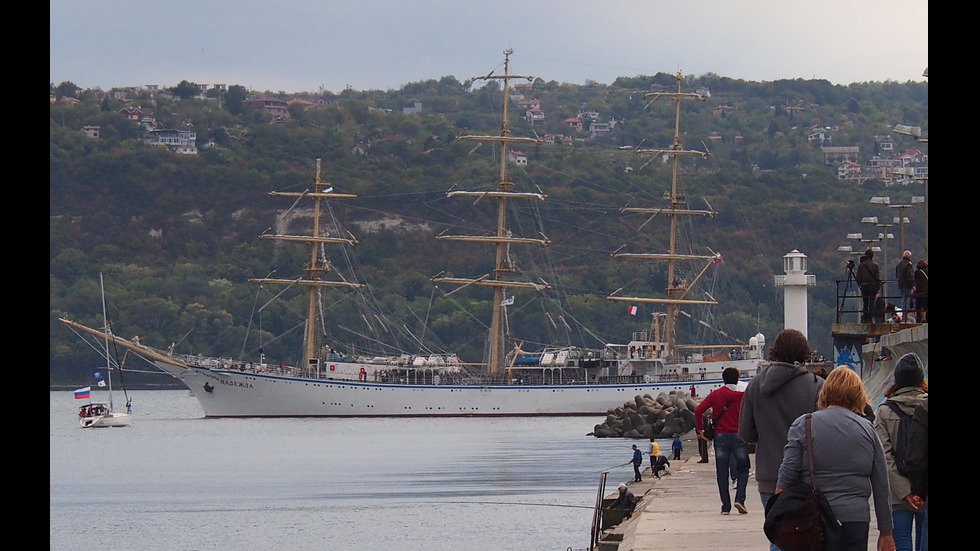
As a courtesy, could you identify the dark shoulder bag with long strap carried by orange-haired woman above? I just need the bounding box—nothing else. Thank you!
[763,413,840,551]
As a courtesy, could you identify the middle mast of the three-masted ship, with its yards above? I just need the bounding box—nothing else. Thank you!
[431,49,551,373]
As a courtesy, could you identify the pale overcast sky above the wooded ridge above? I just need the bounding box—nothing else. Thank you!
[50,0,929,92]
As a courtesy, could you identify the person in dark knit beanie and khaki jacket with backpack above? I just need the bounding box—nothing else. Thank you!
[875,352,929,551]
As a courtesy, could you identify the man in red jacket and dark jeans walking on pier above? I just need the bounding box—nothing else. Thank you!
[694,367,749,515]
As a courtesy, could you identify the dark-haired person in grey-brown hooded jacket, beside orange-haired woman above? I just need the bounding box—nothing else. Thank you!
[738,329,834,551]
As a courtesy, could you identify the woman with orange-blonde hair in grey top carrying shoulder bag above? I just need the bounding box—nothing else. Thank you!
[767,366,895,551]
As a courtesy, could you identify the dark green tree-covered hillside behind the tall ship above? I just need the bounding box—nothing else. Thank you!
[49,73,928,385]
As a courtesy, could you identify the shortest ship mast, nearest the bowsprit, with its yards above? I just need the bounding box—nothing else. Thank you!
[249,159,365,374]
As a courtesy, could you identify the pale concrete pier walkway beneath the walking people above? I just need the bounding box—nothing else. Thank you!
[595,431,878,551]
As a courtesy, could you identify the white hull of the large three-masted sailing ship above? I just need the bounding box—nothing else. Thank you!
[155,360,759,417]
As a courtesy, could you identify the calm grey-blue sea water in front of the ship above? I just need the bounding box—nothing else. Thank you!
[50,390,669,551]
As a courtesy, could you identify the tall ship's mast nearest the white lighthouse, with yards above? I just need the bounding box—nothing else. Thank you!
[607,72,721,358]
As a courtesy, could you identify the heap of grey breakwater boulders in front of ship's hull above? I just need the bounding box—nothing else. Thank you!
[590,390,701,439]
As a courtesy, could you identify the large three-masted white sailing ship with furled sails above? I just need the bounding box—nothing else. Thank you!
[61,50,765,417]
